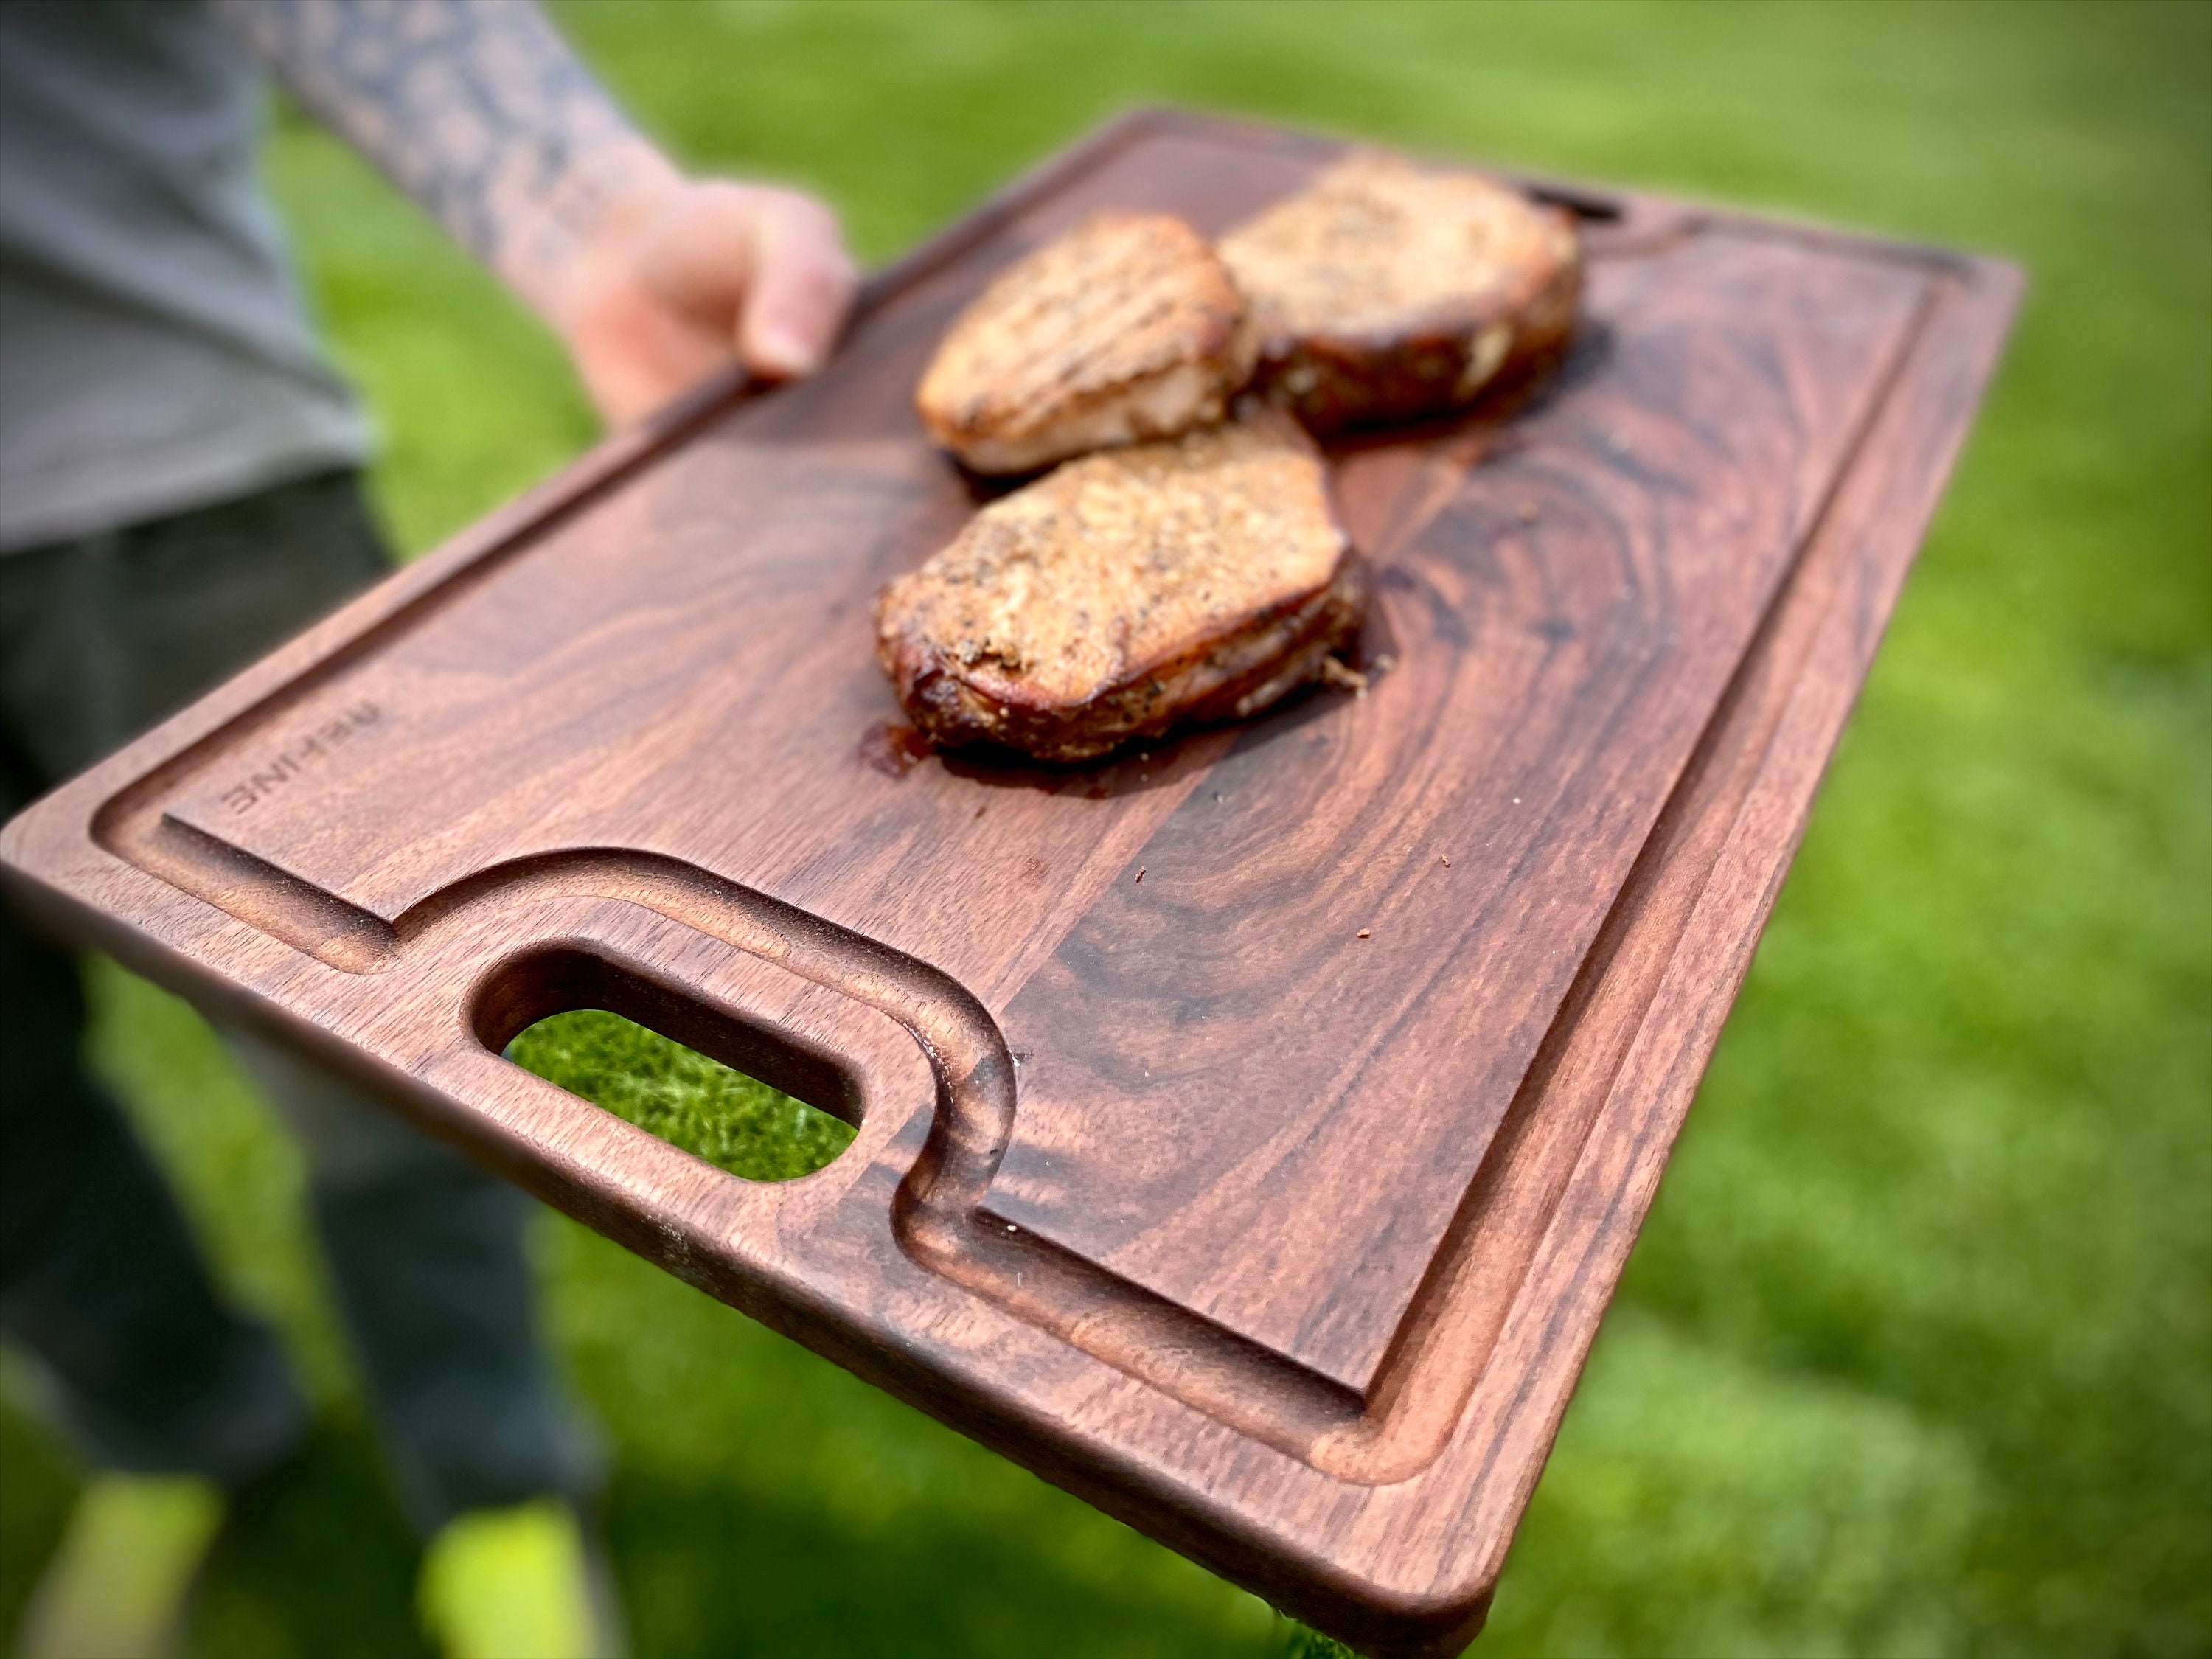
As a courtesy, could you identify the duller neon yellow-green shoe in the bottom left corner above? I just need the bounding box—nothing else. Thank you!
[15,1473,223,1659]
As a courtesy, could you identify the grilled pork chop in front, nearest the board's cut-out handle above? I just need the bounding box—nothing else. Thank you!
[876,414,1365,761]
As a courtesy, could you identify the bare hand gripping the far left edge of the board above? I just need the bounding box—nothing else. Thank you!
[546,177,856,425]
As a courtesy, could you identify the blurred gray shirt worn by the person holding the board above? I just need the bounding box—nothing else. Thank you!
[0,0,367,551]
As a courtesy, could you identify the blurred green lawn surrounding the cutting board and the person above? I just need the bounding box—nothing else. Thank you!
[0,0,2212,1659]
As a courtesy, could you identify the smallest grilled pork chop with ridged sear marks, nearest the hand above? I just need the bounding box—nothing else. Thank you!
[916,212,1254,473]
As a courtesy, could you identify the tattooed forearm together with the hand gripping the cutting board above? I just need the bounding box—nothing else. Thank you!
[215,0,854,425]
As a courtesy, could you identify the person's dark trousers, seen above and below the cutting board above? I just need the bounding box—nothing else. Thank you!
[0,473,593,1531]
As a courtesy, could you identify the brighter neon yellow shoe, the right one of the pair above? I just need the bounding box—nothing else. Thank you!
[416,1498,624,1659]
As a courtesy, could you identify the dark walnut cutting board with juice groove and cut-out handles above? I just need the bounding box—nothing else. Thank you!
[4,113,2020,1652]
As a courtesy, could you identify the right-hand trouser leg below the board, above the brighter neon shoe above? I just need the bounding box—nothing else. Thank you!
[226,1031,599,1533]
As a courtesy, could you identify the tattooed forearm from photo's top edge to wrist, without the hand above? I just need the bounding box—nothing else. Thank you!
[212,0,675,307]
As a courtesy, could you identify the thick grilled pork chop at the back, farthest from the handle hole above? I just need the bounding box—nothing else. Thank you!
[1219,153,1582,434]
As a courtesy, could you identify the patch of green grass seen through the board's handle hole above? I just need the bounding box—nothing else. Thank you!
[507,1009,854,1181]
